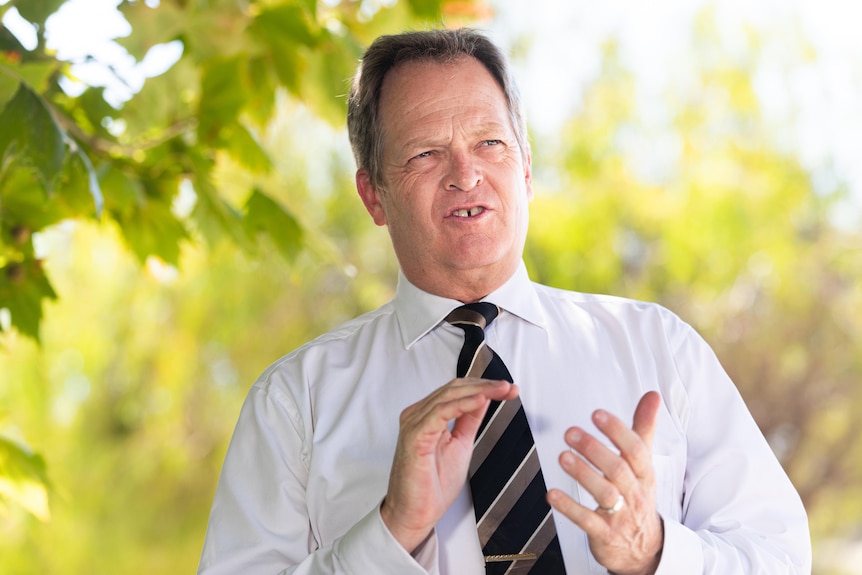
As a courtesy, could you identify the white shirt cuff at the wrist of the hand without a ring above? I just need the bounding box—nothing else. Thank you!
[335,506,438,575]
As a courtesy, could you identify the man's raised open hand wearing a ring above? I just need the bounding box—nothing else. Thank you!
[548,391,664,575]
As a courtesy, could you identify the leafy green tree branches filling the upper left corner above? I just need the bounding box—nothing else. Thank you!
[0,0,482,338]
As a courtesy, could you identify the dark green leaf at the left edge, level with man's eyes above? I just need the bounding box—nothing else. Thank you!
[0,84,66,189]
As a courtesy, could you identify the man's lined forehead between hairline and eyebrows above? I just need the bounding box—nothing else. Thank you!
[380,56,511,141]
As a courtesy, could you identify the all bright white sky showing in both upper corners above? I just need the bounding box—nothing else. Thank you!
[0,0,862,212]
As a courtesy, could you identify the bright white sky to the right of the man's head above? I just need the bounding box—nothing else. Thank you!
[492,0,862,217]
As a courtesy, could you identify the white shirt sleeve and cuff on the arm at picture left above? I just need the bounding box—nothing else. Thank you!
[198,385,437,575]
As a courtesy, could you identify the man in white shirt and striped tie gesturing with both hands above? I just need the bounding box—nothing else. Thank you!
[199,30,810,575]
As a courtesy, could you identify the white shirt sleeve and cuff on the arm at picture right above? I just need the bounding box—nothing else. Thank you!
[657,320,811,575]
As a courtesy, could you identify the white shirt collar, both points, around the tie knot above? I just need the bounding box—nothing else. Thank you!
[393,261,547,349]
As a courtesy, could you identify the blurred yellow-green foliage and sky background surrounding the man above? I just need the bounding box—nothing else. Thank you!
[0,0,862,575]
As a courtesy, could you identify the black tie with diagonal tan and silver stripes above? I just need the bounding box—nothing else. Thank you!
[446,302,566,575]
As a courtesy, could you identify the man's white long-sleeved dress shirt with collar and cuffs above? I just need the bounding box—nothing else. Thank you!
[198,264,811,575]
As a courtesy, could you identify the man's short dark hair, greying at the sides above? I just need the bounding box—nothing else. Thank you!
[347,28,529,189]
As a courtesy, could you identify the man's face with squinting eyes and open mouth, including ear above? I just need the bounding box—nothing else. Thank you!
[356,58,532,301]
